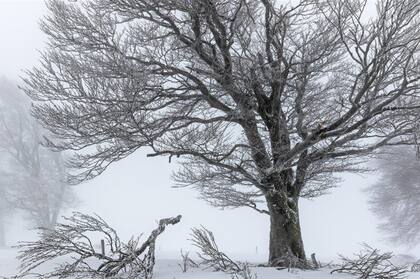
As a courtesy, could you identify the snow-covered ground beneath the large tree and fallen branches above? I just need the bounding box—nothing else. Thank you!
[0,249,420,279]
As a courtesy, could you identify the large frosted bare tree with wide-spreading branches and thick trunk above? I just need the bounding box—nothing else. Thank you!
[24,0,420,265]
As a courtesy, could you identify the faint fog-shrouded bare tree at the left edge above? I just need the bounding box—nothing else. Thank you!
[0,80,73,228]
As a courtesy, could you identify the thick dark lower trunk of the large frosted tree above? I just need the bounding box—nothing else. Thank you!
[266,191,307,268]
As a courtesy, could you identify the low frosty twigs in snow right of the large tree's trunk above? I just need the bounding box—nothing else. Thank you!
[331,244,408,279]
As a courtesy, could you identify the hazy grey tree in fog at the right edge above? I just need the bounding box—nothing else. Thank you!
[367,146,420,244]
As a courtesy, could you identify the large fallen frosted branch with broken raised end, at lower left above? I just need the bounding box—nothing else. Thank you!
[17,212,181,279]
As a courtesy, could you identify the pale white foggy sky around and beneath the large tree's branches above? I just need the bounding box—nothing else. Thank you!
[0,0,420,259]
